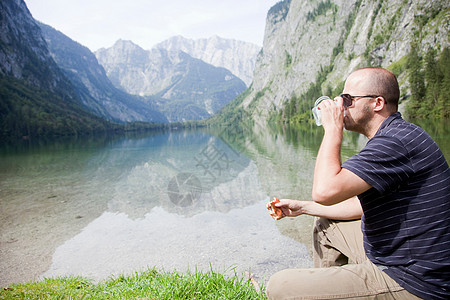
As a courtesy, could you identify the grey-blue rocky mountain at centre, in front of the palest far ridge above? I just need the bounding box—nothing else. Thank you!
[96,40,246,122]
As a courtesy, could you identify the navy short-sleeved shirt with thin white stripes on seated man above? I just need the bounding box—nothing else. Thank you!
[342,113,450,299]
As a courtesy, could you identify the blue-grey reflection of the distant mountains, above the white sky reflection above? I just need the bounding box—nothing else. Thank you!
[102,132,255,218]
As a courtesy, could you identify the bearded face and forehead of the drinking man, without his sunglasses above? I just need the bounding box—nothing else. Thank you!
[343,71,374,133]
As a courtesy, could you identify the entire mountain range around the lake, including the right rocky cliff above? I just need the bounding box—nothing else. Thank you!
[0,0,450,136]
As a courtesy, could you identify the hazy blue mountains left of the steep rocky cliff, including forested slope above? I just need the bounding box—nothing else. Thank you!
[0,0,259,136]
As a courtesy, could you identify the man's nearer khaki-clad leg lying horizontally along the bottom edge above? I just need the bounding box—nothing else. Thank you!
[266,260,420,300]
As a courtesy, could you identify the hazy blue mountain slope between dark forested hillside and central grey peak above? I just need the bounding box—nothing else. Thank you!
[39,23,167,123]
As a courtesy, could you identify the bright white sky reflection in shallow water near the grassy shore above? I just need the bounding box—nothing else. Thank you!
[43,201,310,279]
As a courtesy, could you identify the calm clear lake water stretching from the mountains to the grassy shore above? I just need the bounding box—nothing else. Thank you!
[0,117,450,286]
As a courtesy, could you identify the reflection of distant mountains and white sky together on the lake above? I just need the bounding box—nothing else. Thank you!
[36,131,311,279]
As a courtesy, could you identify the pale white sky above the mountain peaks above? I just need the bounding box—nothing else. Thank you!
[25,0,279,51]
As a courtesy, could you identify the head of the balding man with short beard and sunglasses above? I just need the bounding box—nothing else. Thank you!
[343,68,400,135]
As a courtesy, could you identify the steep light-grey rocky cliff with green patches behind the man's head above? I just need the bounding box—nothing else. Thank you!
[233,0,450,121]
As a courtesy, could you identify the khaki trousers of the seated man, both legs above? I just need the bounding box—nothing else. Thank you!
[267,218,420,300]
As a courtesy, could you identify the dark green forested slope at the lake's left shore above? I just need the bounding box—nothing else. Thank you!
[0,76,168,141]
